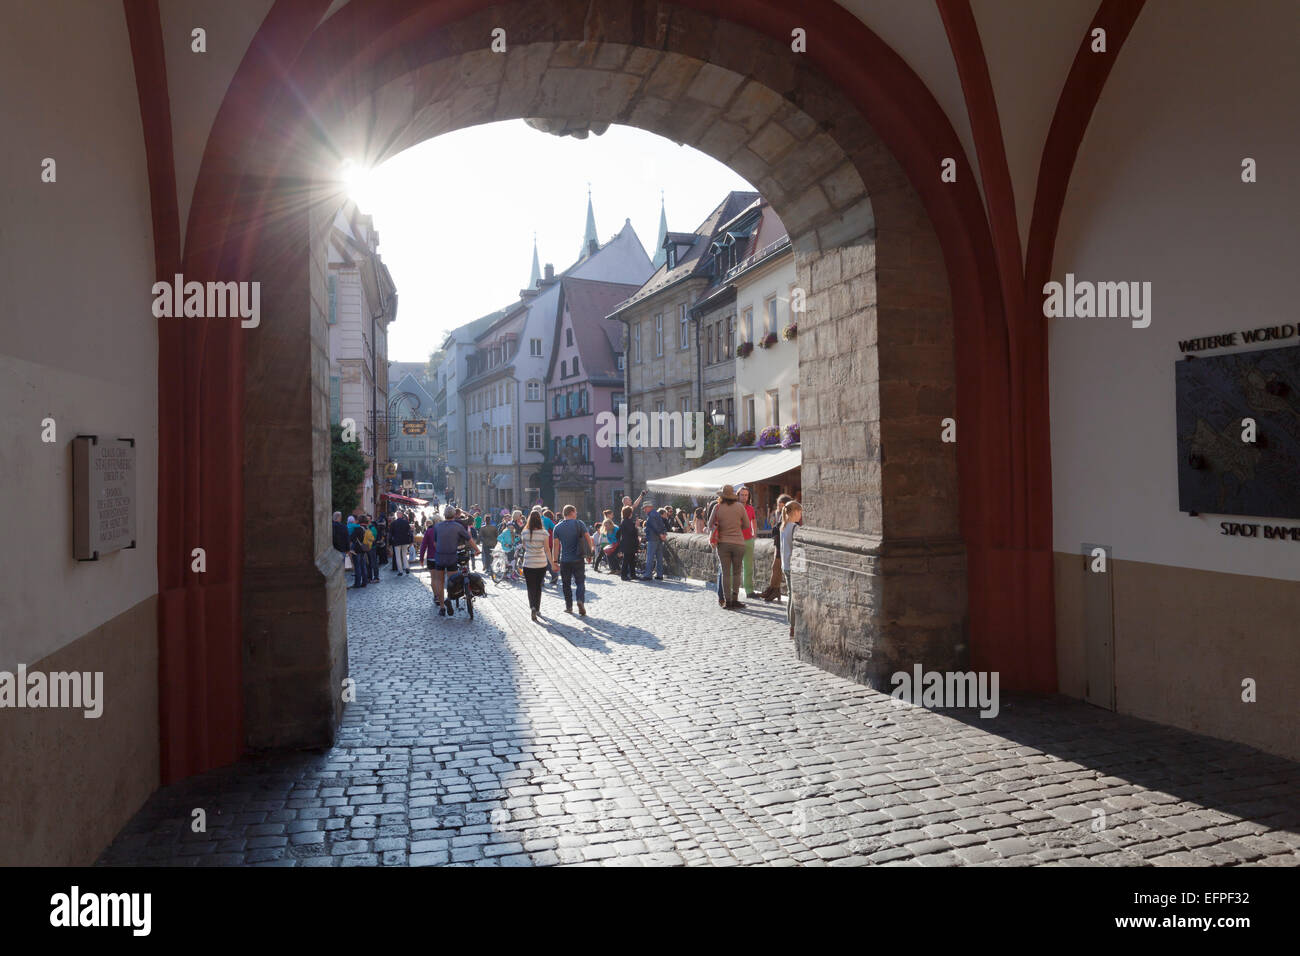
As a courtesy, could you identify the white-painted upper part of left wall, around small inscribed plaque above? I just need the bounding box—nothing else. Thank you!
[0,0,159,670]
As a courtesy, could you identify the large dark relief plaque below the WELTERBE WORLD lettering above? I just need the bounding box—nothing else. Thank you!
[1174,346,1300,518]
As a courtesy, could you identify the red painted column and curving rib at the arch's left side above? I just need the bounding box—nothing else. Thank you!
[156,0,328,783]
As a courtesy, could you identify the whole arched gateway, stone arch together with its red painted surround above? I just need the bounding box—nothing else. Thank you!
[159,0,1056,779]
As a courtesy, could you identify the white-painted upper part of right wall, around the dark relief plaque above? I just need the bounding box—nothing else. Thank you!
[1050,0,1300,580]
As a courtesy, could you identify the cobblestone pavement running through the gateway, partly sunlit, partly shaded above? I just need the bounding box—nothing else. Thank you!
[100,572,1300,866]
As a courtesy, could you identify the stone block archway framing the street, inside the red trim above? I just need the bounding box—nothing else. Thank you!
[165,0,1029,780]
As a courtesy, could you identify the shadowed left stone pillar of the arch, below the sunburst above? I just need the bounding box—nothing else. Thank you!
[242,191,343,750]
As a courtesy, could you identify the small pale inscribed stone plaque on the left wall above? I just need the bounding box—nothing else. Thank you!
[73,434,137,561]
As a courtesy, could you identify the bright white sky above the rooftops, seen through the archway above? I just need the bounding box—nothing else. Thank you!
[350,120,753,362]
